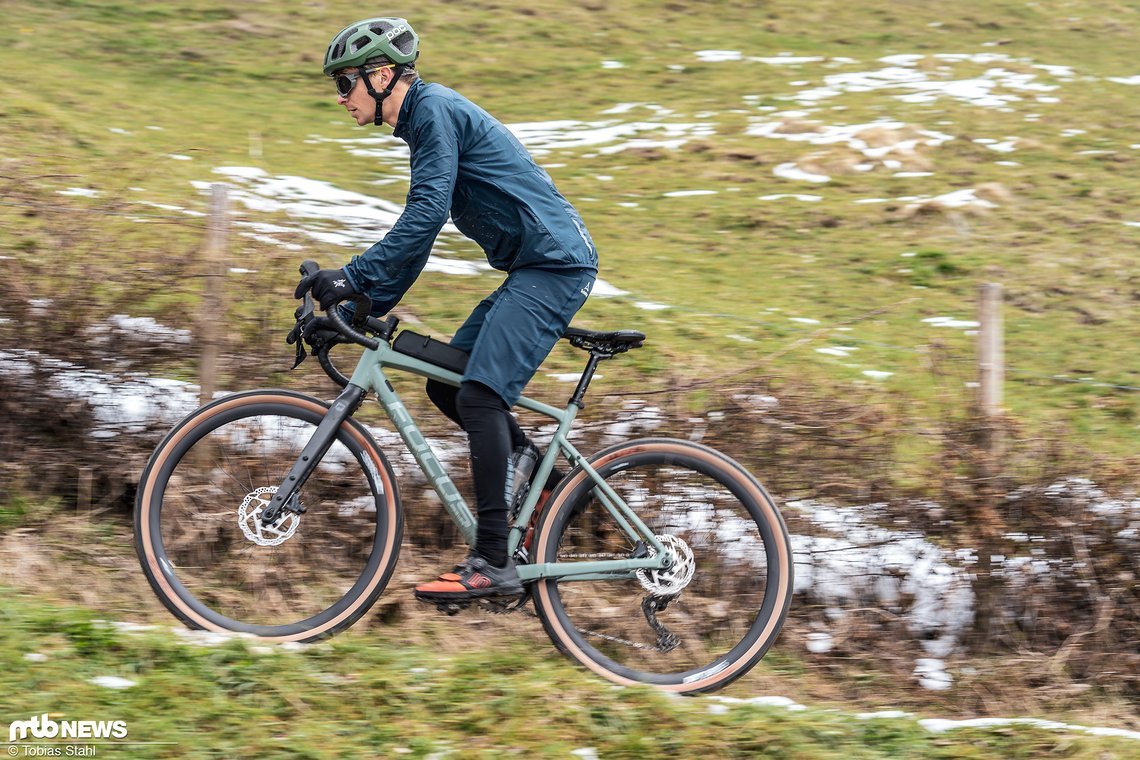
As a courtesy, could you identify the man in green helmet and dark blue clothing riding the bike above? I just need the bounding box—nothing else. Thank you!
[298,18,597,602]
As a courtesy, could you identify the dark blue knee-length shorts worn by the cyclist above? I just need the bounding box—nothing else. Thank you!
[451,268,597,407]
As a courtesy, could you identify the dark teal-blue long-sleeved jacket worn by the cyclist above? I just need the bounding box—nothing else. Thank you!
[344,80,597,313]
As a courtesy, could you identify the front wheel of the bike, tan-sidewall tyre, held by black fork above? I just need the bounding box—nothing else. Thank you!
[135,391,404,641]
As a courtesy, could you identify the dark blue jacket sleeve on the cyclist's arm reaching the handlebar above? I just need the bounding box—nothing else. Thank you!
[344,97,459,300]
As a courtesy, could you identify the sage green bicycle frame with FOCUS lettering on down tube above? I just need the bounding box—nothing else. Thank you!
[349,341,673,581]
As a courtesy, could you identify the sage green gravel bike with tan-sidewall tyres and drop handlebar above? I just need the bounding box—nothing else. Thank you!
[135,262,792,693]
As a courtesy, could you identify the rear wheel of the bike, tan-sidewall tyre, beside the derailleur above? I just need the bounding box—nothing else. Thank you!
[526,439,792,693]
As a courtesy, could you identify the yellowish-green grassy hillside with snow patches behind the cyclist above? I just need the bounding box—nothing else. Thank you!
[0,0,1140,458]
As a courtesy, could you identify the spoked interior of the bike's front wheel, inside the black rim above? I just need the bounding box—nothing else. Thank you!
[149,403,389,626]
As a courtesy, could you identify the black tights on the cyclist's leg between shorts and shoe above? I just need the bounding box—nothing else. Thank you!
[428,381,527,567]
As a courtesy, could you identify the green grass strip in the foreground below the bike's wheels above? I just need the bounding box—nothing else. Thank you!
[0,588,1135,760]
